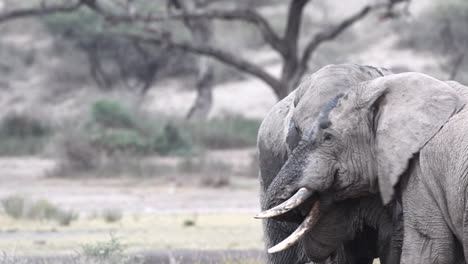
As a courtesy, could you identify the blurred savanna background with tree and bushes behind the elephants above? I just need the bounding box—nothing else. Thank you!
[0,0,468,264]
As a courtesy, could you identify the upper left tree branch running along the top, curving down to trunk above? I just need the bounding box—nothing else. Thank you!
[82,2,286,54]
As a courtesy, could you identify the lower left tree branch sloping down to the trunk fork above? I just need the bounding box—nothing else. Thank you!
[119,33,281,92]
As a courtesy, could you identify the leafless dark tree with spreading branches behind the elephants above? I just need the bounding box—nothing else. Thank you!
[0,0,407,119]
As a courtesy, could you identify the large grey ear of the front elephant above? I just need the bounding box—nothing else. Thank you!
[358,73,465,204]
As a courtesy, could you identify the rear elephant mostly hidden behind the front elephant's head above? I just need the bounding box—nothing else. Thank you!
[258,65,401,264]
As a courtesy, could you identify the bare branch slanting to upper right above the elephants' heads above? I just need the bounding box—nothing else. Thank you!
[300,6,373,76]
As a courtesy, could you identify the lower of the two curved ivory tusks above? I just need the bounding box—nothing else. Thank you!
[268,201,320,253]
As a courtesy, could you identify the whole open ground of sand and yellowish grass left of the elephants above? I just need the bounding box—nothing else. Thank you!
[0,149,263,263]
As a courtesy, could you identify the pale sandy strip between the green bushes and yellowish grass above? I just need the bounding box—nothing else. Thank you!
[0,149,259,215]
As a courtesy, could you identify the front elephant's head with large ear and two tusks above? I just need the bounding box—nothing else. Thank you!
[259,73,464,252]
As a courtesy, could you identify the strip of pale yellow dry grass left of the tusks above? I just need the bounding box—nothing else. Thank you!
[0,214,263,255]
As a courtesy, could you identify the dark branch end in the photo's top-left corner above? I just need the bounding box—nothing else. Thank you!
[0,0,86,23]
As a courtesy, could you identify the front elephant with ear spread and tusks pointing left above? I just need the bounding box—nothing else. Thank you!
[261,72,468,264]
